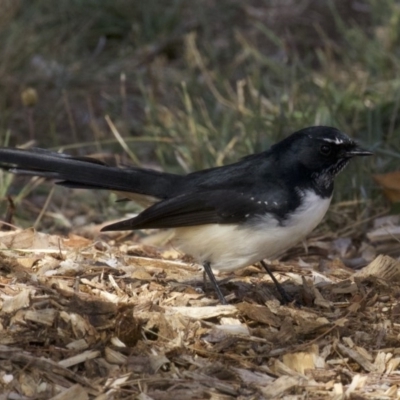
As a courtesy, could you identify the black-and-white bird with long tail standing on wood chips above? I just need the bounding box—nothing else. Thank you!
[0,126,372,304]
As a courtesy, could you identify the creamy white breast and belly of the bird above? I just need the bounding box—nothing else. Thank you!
[173,191,331,271]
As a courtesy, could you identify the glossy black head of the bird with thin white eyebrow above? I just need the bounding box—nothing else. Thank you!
[271,126,372,193]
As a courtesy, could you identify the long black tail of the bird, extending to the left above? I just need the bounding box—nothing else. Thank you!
[0,147,183,199]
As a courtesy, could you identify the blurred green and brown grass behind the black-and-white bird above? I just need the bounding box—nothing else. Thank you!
[0,0,400,231]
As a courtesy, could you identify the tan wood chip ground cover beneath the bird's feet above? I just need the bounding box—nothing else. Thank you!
[0,220,400,400]
